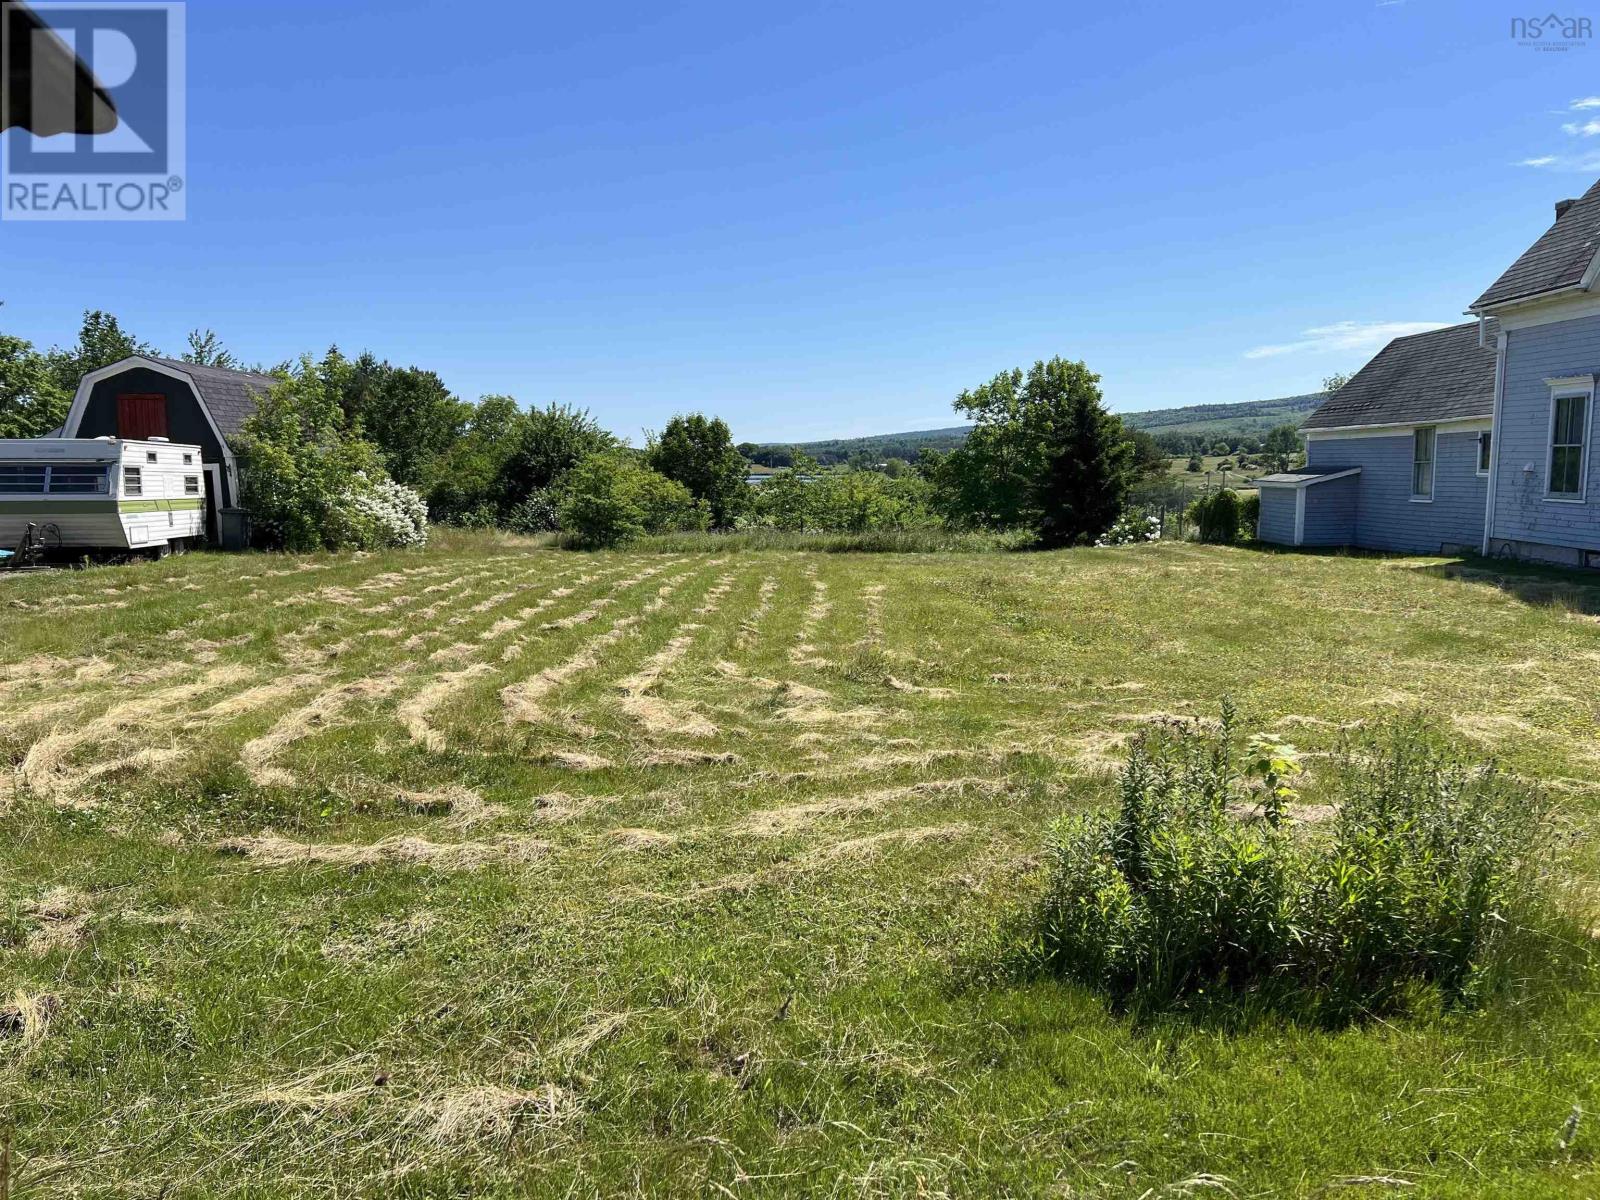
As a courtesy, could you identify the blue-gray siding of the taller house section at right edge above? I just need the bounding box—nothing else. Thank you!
[1491,317,1600,562]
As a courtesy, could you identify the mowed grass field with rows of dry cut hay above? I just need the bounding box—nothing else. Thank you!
[0,536,1600,1197]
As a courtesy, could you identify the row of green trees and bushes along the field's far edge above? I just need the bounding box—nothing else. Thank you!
[0,312,1209,549]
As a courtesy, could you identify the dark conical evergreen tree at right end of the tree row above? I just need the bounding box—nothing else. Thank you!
[1026,358,1134,546]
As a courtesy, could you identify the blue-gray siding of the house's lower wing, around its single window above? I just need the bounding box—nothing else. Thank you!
[1306,432,1488,554]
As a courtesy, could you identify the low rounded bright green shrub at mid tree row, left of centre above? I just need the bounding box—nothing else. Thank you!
[560,451,710,549]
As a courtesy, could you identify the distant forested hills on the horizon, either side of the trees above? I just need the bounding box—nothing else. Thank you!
[739,392,1323,467]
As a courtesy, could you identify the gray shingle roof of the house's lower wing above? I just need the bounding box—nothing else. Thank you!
[1306,322,1496,429]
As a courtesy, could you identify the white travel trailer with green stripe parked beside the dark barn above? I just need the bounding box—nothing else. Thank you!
[0,437,206,555]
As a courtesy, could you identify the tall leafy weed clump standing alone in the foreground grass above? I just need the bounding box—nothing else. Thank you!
[1034,709,1549,1019]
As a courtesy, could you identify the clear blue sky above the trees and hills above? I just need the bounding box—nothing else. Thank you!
[0,0,1600,440]
